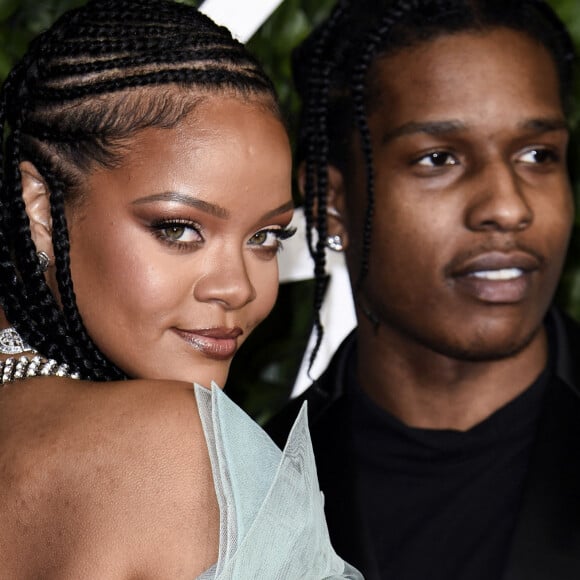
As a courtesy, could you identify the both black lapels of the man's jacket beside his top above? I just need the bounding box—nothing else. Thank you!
[307,309,580,580]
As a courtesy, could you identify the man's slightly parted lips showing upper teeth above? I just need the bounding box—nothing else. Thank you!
[450,250,543,304]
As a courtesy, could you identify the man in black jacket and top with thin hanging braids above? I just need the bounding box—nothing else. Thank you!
[270,0,580,580]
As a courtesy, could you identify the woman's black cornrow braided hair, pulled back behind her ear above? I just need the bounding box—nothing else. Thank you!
[0,0,279,380]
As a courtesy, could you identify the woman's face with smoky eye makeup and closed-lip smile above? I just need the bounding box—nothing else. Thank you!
[62,96,292,385]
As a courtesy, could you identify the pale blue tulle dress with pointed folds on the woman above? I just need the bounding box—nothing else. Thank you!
[195,384,363,580]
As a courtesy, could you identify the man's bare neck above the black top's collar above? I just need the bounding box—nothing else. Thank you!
[357,325,548,431]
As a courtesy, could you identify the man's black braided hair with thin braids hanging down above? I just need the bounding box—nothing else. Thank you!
[293,0,575,365]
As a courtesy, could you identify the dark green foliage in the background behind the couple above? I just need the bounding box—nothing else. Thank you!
[0,0,580,421]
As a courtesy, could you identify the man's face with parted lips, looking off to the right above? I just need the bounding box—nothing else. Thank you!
[345,28,573,360]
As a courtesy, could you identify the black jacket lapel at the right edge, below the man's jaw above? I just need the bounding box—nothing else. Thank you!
[504,311,580,580]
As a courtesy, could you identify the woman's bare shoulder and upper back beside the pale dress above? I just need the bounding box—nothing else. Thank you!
[0,378,219,580]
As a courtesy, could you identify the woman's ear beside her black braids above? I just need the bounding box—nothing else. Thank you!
[19,161,54,259]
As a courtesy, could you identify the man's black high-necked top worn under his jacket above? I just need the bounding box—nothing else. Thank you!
[347,348,551,580]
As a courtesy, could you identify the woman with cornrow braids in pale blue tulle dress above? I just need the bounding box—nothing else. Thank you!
[0,0,358,579]
